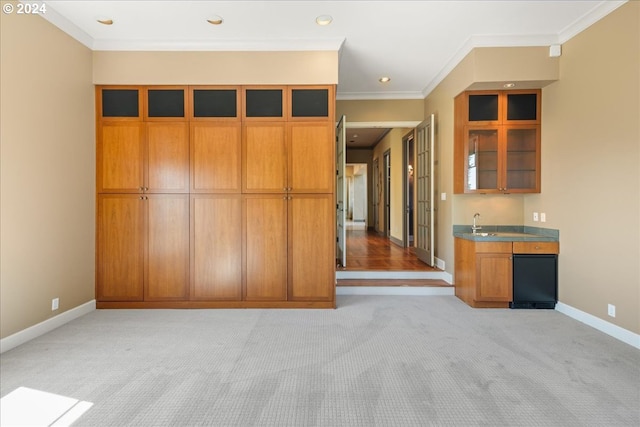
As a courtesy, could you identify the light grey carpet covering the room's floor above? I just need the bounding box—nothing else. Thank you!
[0,296,640,426]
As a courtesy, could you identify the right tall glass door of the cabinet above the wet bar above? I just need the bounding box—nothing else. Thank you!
[506,127,540,191]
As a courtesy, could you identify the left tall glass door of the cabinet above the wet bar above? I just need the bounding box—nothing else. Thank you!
[466,129,498,190]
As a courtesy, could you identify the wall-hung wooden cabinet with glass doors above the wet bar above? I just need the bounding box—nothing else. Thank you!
[454,90,541,193]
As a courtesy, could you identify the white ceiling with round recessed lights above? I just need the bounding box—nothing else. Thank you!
[37,0,624,147]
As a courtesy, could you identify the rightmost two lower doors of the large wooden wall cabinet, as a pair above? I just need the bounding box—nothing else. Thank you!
[245,194,335,302]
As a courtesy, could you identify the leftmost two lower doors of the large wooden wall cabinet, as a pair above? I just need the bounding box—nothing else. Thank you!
[97,194,189,301]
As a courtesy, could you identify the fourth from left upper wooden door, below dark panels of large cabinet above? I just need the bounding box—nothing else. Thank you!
[242,122,287,193]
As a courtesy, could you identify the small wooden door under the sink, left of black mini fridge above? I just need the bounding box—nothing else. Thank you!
[475,253,513,302]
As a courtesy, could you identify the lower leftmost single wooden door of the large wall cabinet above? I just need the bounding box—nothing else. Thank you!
[96,194,146,301]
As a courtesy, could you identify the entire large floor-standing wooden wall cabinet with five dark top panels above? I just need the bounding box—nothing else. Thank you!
[96,86,335,308]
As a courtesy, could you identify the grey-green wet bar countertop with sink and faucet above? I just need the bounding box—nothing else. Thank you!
[453,225,560,242]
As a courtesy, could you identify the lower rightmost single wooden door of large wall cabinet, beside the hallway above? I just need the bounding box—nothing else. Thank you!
[288,194,336,301]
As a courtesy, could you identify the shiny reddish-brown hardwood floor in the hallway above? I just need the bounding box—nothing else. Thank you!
[338,226,438,271]
